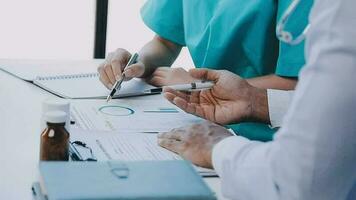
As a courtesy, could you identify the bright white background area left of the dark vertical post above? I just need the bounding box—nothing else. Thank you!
[0,0,95,59]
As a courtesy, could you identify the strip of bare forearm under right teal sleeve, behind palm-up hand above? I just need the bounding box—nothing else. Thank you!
[247,74,298,90]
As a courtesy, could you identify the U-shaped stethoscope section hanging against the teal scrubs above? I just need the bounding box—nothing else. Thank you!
[276,0,310,45]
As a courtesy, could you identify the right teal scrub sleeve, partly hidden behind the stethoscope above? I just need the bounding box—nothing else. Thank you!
[275,0,313,77]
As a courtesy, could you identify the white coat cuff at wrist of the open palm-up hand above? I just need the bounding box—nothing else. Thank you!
[267,89,294,128]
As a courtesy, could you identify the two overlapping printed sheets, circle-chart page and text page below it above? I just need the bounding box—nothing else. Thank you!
[71,96,216,176]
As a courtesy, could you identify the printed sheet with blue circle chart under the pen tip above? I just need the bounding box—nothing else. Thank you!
[71,96,203,132]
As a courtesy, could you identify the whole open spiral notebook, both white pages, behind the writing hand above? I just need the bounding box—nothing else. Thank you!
[0,59,155,99]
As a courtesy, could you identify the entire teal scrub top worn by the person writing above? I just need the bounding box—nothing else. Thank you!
[141,0,310,141]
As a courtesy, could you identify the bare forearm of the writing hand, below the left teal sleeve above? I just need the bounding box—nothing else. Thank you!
[139,36,182,78]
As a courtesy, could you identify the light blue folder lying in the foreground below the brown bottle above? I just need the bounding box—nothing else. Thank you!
[36,161,216,200]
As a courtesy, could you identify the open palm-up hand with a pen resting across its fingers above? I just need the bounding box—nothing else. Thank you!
[163,69,269,125]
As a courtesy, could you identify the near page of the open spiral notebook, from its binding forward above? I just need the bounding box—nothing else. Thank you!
[33,73,155,99]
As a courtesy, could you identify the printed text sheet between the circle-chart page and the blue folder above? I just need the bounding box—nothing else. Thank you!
[71,129,216,176]
